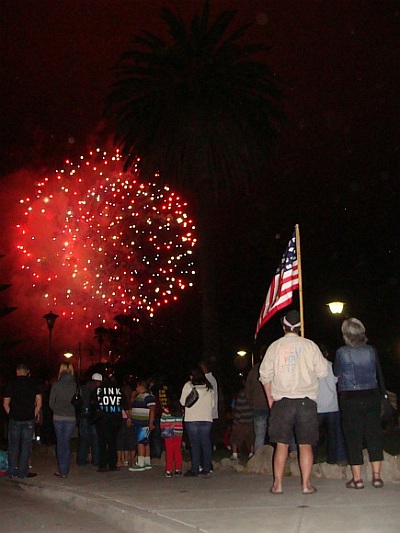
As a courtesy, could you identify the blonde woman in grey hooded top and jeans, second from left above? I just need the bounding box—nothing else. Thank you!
[49,361,76,478]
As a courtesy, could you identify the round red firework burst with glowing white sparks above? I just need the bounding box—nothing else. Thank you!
[18,149,196,328]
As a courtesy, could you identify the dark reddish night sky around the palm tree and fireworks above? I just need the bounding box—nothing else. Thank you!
[0,0,400,381]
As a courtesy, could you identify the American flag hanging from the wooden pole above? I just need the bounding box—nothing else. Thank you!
[255,231,299,337]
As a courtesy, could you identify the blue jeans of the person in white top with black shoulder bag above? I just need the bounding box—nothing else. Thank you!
[185,422,212,474]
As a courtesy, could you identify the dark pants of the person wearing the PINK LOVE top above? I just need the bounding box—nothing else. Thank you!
[96,414,122,470]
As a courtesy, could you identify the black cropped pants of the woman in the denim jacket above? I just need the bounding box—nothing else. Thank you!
[340,392,383,465]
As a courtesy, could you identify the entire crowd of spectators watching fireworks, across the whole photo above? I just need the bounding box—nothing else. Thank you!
[3,311,390,494]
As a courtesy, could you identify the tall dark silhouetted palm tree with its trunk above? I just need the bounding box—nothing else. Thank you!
[105,2,283,357]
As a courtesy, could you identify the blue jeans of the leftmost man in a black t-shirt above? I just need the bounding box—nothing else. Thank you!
[8,418,35,477]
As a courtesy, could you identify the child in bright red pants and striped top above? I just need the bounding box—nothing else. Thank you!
[160,394,183,477]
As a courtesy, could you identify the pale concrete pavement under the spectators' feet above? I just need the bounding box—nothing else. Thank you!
[0,447,400,533]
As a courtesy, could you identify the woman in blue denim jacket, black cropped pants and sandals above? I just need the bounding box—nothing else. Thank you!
[334,318,383,489]
